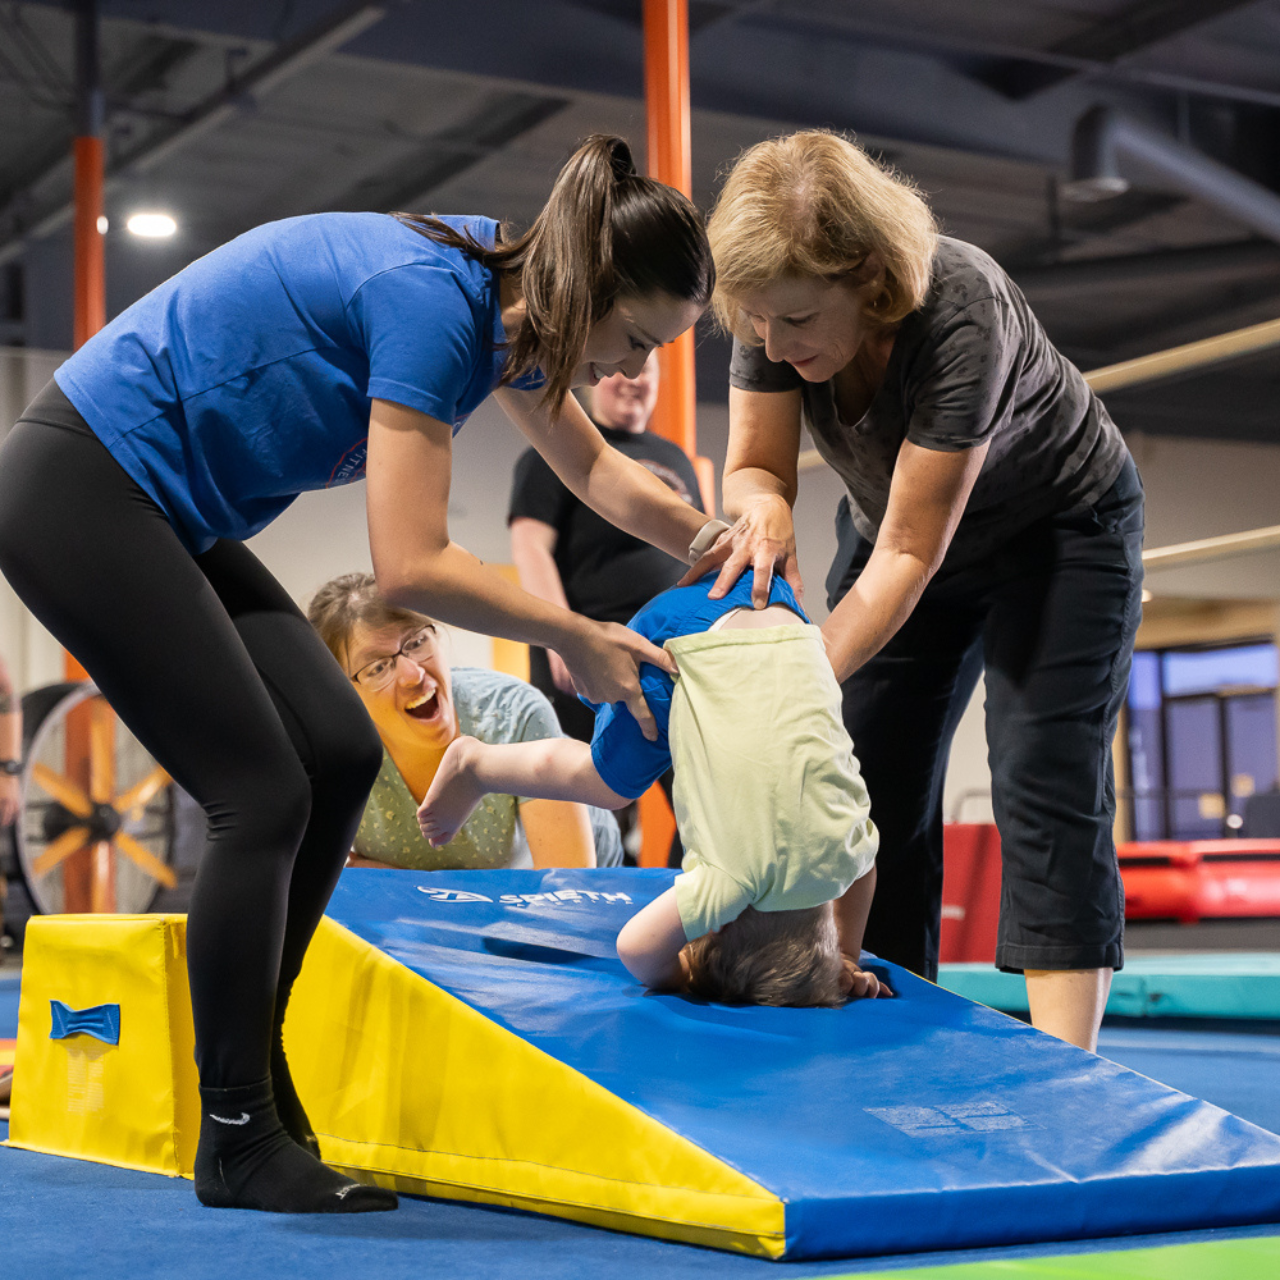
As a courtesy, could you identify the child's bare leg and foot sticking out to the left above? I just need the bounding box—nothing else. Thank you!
[417,737,631,846]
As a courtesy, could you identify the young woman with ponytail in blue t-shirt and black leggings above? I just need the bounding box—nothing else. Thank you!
[0,137,732,1212]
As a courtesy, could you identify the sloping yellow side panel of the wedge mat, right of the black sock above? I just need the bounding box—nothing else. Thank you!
[284,919,785,1257]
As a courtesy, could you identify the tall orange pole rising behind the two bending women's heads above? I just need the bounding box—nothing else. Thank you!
[644,0,714,458]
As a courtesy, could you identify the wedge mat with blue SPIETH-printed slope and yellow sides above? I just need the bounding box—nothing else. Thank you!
[13,870,1280,1258]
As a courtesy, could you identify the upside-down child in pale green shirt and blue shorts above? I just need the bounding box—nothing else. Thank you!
[419,572,890,1005]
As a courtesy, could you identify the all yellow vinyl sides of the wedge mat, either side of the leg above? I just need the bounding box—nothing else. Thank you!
[9,915,785,1257]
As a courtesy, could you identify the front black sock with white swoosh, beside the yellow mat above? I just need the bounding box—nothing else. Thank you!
[196,1079,398,1213]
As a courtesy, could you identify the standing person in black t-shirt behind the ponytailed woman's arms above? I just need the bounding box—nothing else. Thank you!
[507,355,703,867]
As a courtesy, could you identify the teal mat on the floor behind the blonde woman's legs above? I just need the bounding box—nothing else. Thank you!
[938,951,1280,1019]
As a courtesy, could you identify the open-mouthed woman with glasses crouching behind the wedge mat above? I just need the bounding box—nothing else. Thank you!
[307,573,622,870]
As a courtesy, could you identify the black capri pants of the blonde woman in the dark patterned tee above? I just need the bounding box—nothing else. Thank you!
[827,460,1143,980]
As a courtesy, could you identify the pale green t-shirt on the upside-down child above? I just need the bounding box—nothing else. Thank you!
[664,623,879,940]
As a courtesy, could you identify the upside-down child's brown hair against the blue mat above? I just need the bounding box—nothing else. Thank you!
[685,904,846,1007]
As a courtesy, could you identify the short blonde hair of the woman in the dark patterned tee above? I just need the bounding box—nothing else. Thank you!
[707,129,938,346]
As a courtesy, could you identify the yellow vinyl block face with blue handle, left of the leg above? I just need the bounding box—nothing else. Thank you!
[9,915,200,1178]
